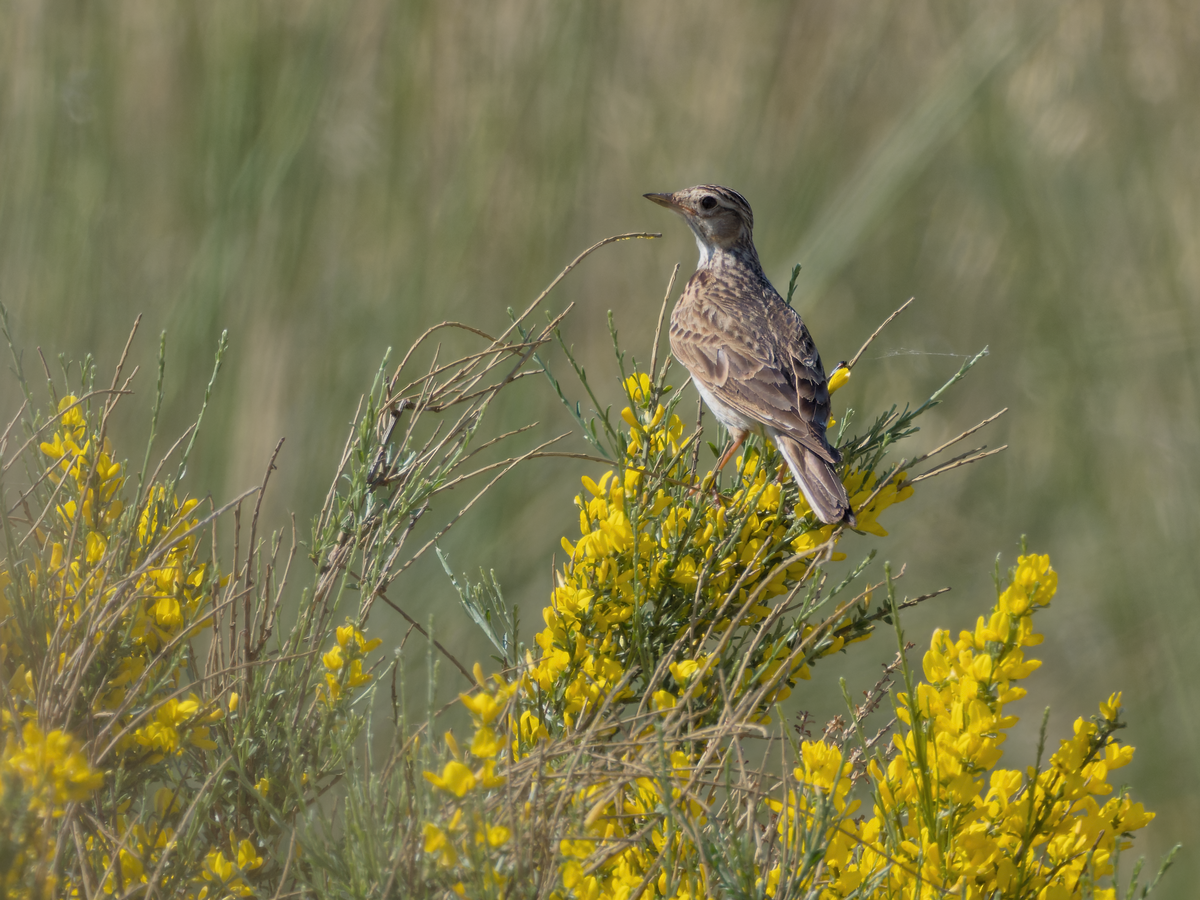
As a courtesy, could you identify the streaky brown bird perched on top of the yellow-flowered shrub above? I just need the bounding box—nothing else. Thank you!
[643,185,856,527]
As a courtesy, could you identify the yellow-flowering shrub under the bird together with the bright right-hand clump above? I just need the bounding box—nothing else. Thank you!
[422,355,1171,900]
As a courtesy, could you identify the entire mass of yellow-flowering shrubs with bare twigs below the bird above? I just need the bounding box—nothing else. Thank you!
[0,256,1153,900]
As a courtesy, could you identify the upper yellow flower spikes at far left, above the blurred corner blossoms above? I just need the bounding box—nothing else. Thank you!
[0,395,215,763]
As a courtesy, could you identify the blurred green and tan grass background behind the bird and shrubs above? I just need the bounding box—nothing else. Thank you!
[0,0,1200,898]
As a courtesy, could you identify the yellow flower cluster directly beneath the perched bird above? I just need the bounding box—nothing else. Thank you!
[528,374,912,727]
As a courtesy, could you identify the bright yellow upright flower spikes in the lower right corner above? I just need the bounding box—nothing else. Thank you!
[753,554,1153,900]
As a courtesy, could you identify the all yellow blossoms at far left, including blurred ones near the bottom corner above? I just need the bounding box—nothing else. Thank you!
[0,395,231,896]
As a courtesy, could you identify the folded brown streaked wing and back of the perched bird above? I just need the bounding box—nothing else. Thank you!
[671,282,841,463]
